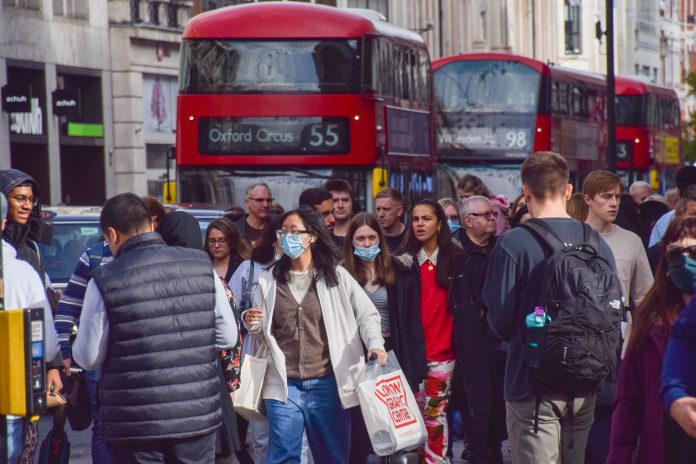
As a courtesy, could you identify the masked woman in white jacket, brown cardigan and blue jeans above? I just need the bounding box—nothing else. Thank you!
[243,207,387,463]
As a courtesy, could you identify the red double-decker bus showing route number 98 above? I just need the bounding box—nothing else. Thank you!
[433,53,607,198]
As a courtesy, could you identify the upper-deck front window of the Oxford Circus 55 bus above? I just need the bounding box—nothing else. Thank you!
[179,39,359,94]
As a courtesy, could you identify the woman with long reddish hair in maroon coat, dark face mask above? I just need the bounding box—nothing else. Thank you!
[606,217,696,464]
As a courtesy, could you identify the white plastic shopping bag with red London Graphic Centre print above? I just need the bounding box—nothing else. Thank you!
[358,351,428,456]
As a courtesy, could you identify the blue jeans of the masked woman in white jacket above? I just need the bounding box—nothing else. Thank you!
[264,375,350,464]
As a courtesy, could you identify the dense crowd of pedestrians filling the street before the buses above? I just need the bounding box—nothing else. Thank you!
[0,156,696,464]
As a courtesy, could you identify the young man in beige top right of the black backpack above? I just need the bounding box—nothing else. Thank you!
[582,170,654,464]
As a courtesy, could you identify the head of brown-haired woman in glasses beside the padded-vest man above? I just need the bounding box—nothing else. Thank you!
[203,217,251,283]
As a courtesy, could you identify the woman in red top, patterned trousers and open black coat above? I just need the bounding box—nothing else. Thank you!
[396,199,491,463]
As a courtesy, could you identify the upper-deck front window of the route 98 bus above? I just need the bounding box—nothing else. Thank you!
[434,60,541,113]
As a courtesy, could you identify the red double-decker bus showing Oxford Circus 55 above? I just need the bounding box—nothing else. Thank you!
[176,2,434,208]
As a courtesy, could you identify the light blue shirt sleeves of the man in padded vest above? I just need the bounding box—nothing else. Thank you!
[73,271,239,370]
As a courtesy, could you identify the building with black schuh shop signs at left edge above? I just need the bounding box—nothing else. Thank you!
[0,0,114,204]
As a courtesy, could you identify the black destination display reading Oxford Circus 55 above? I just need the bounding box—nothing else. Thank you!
[198,116,350,155]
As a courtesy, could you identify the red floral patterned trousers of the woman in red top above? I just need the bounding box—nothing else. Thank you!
[415,360,454,463]
